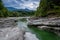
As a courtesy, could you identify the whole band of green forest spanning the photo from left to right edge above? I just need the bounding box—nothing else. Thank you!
[0,0,60,17]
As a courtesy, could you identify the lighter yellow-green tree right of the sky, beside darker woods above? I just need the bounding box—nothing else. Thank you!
[35,0,48,16]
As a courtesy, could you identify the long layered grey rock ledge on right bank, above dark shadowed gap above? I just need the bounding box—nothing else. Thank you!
[28,18,60,27]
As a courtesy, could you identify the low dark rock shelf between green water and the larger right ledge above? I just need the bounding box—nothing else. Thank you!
[38,26,60,36]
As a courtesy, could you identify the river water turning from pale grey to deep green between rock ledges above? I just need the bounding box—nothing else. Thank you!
[18,19,60,40]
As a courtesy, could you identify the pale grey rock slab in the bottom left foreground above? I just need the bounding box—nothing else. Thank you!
[0,27,23,40]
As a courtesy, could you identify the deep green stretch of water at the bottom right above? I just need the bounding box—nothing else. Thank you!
[29,27,60,40]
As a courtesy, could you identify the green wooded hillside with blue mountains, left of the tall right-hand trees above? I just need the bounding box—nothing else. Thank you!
[0,0,35,17]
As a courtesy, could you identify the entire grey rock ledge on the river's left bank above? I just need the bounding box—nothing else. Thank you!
[0,18,24,40]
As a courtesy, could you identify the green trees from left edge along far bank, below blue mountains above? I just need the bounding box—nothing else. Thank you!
[0,0,34,17]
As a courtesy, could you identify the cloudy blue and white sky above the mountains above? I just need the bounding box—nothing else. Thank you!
[2,0,40,10]
